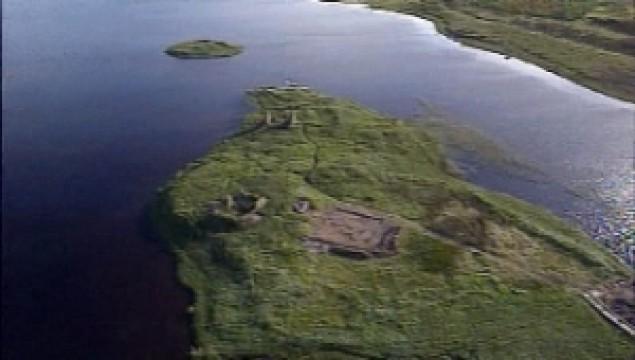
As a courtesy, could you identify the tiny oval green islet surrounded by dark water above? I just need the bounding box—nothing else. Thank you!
[165,40,243,59]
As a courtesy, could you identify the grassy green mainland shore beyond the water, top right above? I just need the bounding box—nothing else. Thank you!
[331,0,635,102]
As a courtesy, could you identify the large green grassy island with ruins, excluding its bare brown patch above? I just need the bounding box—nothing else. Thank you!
[153,89,635,360]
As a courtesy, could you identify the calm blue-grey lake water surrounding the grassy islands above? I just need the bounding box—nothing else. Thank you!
[2,0,634,359]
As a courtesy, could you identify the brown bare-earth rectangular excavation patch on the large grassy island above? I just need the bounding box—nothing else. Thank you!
[301,206,400,259]
